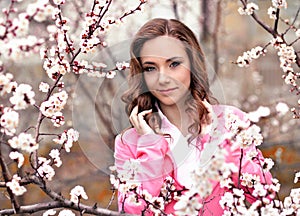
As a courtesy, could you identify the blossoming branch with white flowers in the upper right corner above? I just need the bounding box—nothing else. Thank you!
[236,0,300,119]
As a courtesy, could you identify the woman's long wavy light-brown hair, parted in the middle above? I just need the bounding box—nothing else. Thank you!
[122,18,217,142]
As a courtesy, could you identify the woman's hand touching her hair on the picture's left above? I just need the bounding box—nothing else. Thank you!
[129,106,154,135]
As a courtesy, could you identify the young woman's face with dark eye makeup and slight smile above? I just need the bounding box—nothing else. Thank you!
[140,36,191,108]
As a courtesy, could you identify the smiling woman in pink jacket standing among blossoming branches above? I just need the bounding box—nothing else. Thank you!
[115,19,271,215]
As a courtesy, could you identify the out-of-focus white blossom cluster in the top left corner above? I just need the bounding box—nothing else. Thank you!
[0,0,54,61]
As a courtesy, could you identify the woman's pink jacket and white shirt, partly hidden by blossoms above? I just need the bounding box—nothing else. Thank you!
[114,105,272,216]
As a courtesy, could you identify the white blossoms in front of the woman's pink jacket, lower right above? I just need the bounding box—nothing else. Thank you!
[110,107,300,216]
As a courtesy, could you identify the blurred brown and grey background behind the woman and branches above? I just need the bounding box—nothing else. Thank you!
[0,0,300,215]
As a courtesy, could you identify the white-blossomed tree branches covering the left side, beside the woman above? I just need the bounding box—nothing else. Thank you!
[0,0,145,215]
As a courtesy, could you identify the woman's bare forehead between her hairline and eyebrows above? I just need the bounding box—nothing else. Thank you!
[140,36,187,59]
